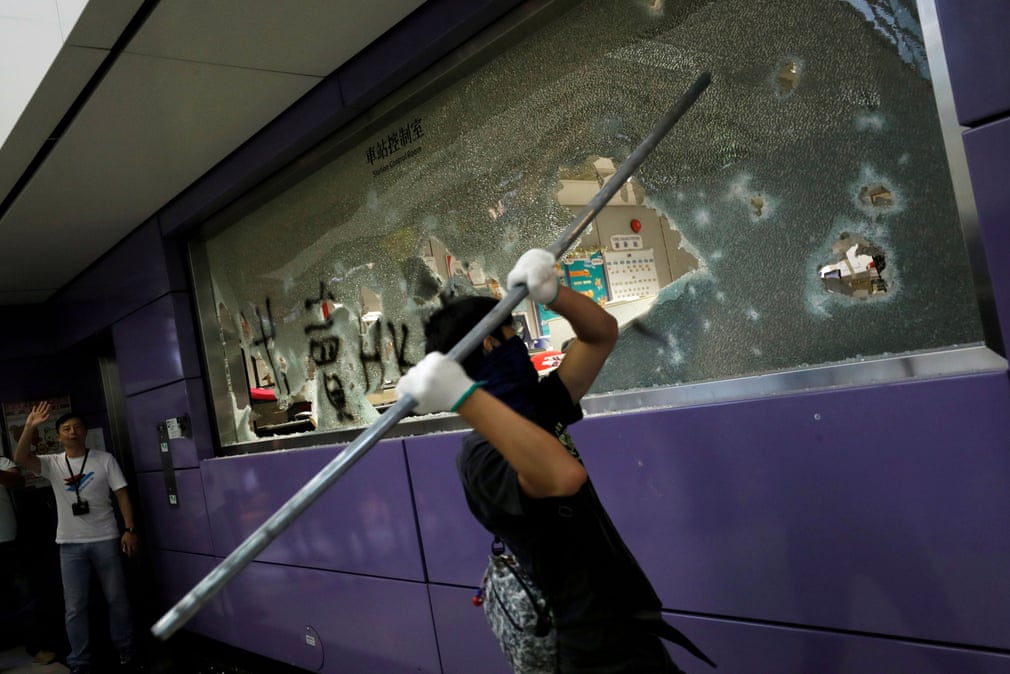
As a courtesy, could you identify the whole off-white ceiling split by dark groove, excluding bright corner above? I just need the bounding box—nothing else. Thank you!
[0,0,423,305]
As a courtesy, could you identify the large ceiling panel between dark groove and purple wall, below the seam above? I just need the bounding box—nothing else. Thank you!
[0,55,318,289]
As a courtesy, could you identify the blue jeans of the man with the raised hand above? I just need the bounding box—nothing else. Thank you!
[60,539,133,668]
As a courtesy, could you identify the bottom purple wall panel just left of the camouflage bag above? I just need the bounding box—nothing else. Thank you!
[428,586,512,674]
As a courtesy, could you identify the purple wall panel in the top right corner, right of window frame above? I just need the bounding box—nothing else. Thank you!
[936,0,1010,126]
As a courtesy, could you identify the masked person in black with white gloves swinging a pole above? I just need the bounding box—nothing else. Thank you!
[397,249,711,674]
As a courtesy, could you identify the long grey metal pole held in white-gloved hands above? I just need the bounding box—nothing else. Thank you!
[150,73,712,640]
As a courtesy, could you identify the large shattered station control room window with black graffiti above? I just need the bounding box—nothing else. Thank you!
[192,0,983,442]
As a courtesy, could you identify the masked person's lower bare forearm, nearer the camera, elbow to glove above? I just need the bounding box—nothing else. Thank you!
[457,389,586,498]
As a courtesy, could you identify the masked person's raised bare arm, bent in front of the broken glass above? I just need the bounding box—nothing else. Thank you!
[550,286,617,402]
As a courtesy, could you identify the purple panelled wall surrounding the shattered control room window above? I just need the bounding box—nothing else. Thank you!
[0,0,1010,674]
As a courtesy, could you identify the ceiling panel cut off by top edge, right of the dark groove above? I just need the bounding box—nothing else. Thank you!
[127,0,423,77]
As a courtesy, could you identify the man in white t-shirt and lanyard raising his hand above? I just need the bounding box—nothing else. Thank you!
[14,402,137,674]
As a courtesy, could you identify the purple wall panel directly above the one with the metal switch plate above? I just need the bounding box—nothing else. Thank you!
[112,293,200,395]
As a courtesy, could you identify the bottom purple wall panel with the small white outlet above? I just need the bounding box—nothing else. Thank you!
[227,561,441,674]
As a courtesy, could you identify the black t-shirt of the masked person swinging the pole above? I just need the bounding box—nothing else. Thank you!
[457,373,676,672]
